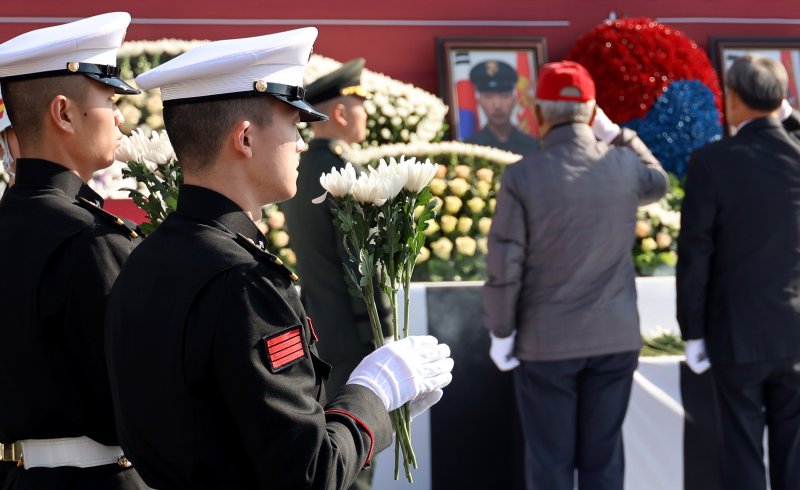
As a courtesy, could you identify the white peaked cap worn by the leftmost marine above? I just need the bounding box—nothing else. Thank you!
[0,12,138,93]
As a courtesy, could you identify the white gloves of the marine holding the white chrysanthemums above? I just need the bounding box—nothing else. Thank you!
[347,335,453,412]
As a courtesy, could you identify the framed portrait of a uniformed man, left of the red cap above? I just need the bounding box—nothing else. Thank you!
[437,37,546,155]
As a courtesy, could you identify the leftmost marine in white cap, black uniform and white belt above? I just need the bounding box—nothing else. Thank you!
[0,12,148,490]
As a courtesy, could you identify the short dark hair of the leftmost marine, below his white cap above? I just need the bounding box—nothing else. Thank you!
[0,75,89,143]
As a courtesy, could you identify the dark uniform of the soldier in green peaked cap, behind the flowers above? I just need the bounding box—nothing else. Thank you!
[280,139,392,391]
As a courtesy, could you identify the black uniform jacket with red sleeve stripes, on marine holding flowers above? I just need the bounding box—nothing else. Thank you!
[107,185,392,490]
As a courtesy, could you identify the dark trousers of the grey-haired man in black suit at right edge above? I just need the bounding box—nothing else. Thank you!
[712,359,800,490]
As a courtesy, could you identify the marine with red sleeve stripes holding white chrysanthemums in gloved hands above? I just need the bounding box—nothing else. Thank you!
[106,28,453,489]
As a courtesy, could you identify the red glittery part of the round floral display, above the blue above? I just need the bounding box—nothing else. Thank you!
[566,18,723,123]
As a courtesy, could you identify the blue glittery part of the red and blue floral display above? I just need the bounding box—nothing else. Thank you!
[623,80,722,178]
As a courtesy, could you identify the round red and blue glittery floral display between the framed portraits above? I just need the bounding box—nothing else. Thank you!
[567,18,722,177]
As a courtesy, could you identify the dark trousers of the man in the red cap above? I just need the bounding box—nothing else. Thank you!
[514,352,639,490]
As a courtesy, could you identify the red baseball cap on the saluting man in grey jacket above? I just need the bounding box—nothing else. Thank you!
[536,61,594,102]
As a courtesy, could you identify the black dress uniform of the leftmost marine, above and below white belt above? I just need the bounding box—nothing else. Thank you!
[0,158,147,489]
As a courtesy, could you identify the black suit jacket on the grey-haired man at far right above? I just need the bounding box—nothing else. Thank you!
[677,118,800,363]
